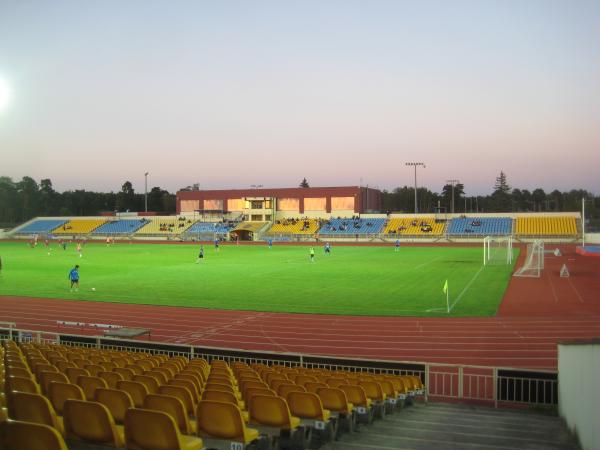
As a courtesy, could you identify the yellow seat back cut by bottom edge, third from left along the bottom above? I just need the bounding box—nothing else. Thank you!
[125,408,181,450]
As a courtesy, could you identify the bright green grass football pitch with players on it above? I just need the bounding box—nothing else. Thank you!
[0,242,518,316]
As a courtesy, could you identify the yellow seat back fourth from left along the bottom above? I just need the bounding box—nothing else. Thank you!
[196,400,246,442]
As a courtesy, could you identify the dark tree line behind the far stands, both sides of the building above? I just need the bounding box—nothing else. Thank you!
[0,172,600,226]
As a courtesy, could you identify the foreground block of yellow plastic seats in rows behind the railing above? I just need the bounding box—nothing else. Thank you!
[0,340,425,449]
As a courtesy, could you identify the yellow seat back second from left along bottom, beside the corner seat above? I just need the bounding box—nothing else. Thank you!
[63,400,123,447]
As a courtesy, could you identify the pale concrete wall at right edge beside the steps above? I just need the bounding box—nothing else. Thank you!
[558,339,600,450]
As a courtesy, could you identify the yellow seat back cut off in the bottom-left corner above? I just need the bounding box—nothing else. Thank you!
[0,420,68,450]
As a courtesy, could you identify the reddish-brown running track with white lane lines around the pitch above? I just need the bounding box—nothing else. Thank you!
[0,244,600,370]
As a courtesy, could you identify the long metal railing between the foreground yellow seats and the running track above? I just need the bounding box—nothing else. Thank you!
[0,323,558,407]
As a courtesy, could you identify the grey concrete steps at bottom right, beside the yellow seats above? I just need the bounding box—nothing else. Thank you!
[321,403,579,450]
